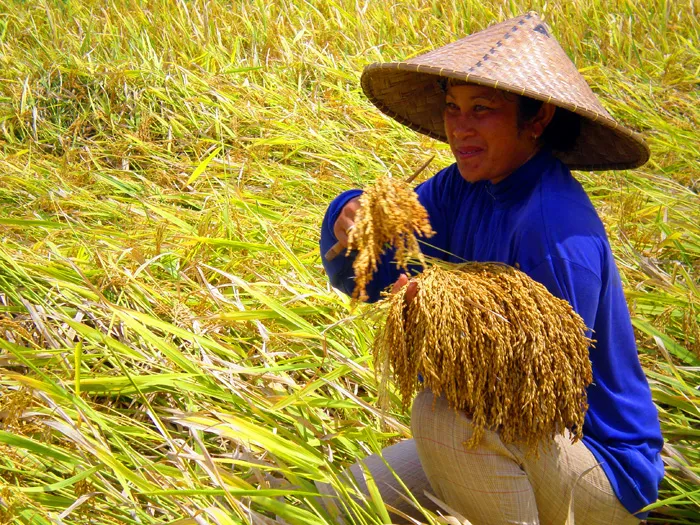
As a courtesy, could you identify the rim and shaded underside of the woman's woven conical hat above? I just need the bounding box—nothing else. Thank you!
[361,62,649,171]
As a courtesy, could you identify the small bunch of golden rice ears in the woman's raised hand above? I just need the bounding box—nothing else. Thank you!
[348,177,435,301]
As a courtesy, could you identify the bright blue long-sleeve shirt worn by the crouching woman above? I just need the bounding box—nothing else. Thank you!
[321,150,664,518]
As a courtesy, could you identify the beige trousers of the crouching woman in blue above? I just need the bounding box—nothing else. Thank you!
[322,390,639,525]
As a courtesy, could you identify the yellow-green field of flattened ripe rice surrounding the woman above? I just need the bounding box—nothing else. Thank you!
[0,0,700,525]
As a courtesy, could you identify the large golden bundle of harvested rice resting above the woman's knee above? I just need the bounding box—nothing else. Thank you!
[374,263,592,453]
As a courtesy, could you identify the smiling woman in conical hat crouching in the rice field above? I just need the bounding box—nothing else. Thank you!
[321,13,663,525]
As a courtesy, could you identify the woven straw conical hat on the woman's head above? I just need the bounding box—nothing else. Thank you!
[362,13,649,170]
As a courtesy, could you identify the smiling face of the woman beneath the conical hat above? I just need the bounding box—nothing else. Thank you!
[444,84,553,184]
